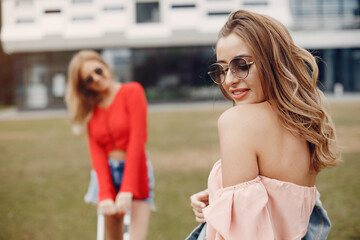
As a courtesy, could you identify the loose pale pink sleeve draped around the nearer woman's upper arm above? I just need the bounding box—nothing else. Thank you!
[203,177,274,240]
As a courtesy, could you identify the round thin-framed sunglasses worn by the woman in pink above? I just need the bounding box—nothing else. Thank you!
[208,57,254,84]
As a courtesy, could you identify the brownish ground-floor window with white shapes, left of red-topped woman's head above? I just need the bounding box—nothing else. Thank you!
[13,51,75,109]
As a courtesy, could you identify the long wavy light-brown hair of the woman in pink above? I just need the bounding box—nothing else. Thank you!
[218,10,340,172]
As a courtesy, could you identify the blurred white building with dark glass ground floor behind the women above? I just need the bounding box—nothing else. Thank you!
[1,0,360,109]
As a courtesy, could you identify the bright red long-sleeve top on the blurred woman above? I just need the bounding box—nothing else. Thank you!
[88,82,149,201]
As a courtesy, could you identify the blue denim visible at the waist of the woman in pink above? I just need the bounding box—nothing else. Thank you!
[185,192,331,240]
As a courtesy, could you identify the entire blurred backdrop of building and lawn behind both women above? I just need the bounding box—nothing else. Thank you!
[0,0,360,240]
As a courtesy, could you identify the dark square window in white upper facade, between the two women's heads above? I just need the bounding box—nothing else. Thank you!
[136,2,160,23]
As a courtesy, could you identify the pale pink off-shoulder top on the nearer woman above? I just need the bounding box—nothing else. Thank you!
[203,160,316,240]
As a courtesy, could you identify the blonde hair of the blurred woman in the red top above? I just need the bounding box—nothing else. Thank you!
[65,50,112,134]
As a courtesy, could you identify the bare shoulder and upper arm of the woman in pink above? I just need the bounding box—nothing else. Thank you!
[218,103,271,187]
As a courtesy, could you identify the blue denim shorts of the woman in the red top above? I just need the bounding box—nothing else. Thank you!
[84,159,155,206]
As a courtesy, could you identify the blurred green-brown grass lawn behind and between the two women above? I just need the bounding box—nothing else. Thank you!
[0,103,360,240]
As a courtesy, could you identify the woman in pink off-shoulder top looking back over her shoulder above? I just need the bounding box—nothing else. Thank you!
[190,10,339,240]
